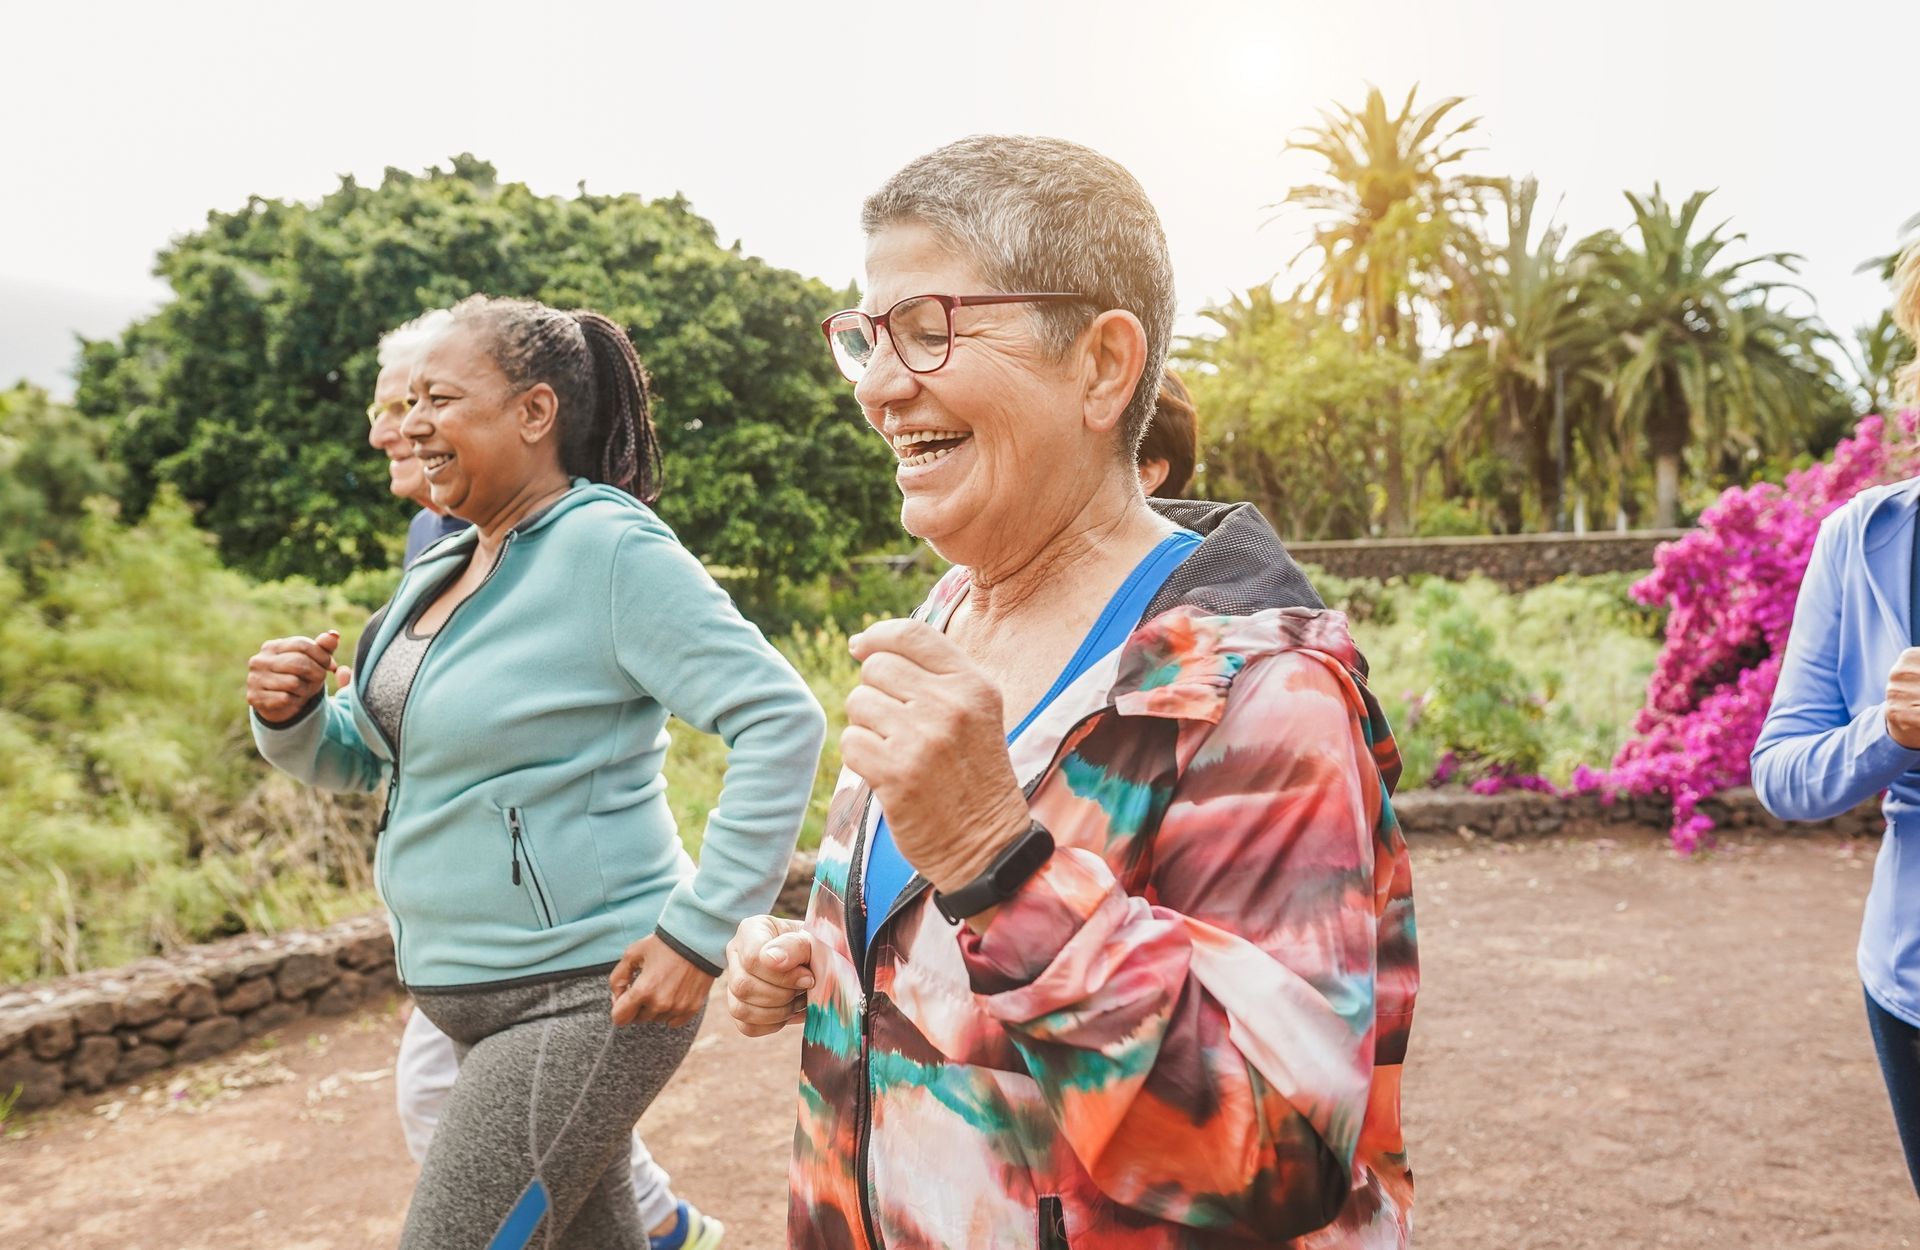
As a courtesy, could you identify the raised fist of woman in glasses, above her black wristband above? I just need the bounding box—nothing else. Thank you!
[841,620,1031,891]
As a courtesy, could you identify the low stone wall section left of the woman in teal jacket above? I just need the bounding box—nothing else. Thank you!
[0,916,399,1108]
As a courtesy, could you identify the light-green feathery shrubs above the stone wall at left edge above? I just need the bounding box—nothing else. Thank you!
[0,493,372,981]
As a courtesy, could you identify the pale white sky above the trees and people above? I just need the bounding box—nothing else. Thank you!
[0,0,1920,390]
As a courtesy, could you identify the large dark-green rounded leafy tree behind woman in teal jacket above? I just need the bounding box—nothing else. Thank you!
[79,156,897,582]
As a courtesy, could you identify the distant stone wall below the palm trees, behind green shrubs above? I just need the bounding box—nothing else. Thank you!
[1286,530,1686,589]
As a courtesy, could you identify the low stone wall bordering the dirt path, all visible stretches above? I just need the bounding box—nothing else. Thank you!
[0,789,1884,1110]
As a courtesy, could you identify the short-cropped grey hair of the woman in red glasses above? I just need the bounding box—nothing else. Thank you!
[860,134,1173,457]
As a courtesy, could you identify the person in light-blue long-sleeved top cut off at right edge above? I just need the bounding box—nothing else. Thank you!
[1753,246,1920,1189]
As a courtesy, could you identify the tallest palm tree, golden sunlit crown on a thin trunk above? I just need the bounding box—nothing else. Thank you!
[1281,84,1494,534]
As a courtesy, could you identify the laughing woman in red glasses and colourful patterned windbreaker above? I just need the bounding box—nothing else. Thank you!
[728,136,1417,1250]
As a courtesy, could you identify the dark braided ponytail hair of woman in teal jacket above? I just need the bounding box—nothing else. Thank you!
[453,296,660,503]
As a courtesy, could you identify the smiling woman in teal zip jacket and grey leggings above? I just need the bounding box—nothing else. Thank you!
[248,296,826,1250]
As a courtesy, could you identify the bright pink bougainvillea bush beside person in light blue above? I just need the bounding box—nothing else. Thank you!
[1572,411,1920,851]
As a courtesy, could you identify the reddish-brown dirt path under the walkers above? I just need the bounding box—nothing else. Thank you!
[0,839,1920,1250]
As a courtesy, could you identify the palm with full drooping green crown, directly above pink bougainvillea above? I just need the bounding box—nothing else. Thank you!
[1576,186,1837,528]
